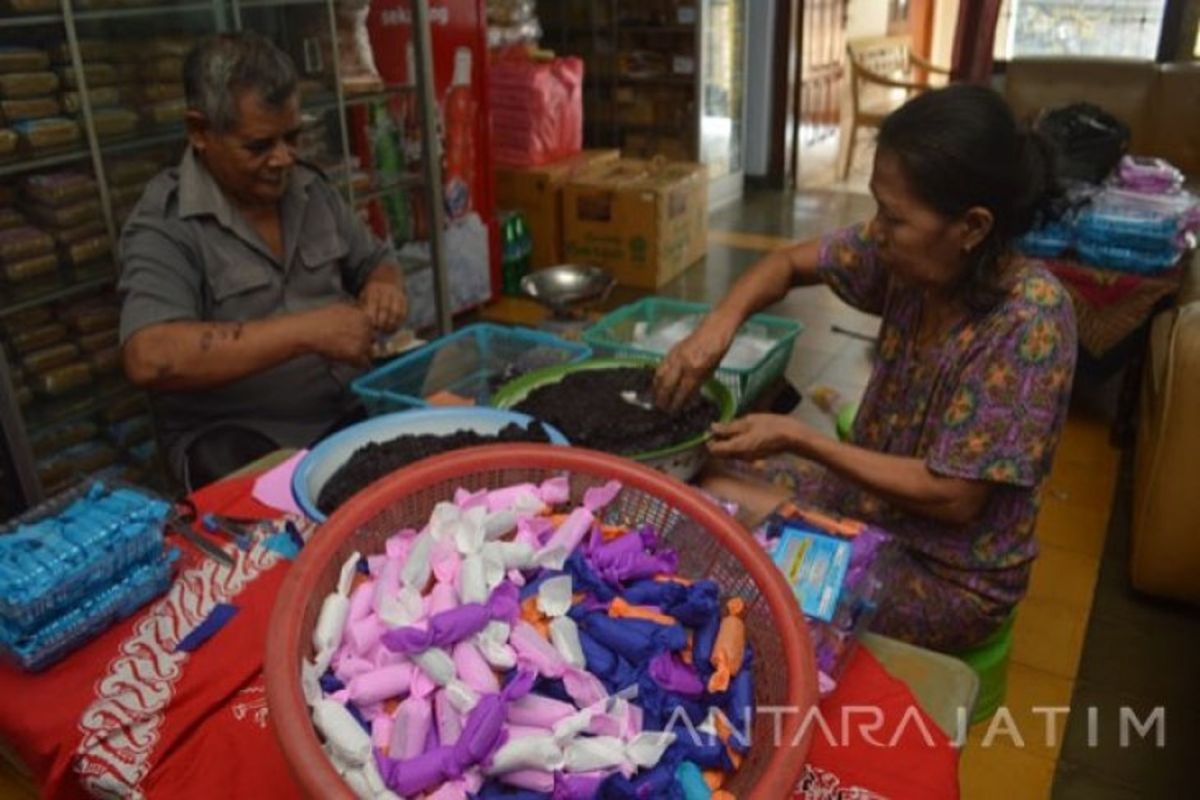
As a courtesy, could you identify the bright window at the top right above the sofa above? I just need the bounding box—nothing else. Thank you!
[995,0,1166,61]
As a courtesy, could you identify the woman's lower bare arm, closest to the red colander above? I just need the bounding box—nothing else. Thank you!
[709,414,991,525]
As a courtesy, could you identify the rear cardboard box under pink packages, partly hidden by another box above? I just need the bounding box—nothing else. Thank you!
[496,150,620,270]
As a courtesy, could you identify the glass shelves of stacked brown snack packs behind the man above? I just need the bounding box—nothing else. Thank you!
[0,0,451,517]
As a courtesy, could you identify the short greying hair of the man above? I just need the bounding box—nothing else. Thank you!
[184,32,296,133]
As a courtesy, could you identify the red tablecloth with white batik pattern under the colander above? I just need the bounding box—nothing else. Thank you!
[0,476,958,800]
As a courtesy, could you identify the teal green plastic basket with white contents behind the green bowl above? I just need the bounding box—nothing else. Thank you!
[583,297,804,410]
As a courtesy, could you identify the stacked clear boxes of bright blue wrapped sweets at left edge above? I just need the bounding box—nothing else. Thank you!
[0,482,175,670]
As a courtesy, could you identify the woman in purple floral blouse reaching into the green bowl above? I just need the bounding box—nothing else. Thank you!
[655,85,1075,651]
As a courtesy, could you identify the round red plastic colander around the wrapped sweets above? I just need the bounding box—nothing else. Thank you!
[265,444,817,800]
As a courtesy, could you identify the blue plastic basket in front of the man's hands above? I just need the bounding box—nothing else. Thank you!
[350,323,592,416]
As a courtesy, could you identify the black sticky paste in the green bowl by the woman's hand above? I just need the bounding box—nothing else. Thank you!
[515,367,720,456]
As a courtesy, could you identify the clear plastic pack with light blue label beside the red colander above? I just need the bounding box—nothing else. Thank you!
[756,504,895,696]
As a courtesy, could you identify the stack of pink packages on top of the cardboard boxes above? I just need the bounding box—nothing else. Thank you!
[487,48,583,167]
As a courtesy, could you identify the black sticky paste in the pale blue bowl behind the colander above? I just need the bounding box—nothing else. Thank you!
[317,421,550,515]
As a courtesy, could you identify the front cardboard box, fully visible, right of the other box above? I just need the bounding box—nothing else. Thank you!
[563,160,708,289]
